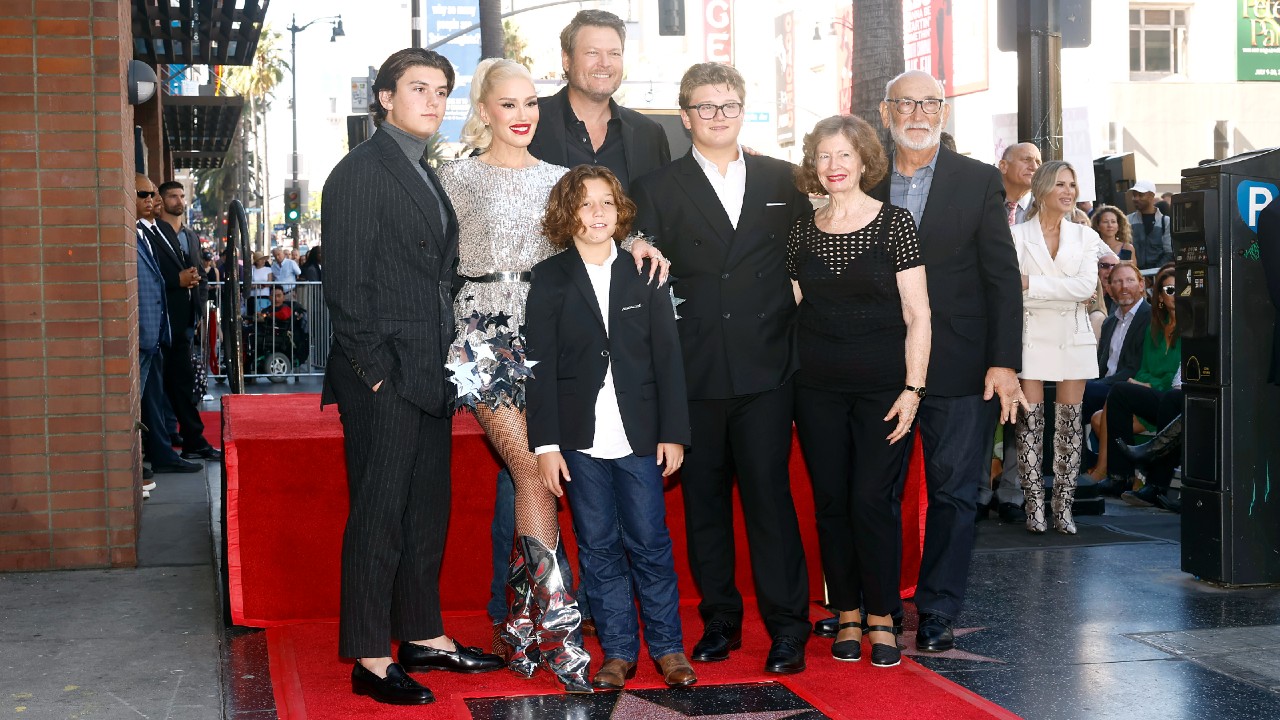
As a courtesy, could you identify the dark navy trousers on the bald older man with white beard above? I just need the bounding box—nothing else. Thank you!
[915,395,1000,620]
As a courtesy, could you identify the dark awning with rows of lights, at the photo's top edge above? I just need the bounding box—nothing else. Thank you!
[132,0,271,65]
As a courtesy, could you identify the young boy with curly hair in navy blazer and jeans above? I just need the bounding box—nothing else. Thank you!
[525,165,696,689]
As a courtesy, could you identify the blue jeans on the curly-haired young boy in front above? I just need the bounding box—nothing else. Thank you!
[564,451,684,662]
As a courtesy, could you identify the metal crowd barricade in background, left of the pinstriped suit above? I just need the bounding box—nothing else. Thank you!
[196,282,329,383]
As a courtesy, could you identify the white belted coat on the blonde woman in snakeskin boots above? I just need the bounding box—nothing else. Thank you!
[1010,217,1108,382]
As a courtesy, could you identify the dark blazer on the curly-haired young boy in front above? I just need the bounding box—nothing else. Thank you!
[525,246,690,455]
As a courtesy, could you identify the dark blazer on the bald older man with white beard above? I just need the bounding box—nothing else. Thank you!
[872,147,1023,397]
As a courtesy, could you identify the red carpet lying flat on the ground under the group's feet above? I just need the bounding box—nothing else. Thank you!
[266,606,1016,720]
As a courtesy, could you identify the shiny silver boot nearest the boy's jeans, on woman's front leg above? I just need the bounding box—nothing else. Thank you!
[520,536,594,693]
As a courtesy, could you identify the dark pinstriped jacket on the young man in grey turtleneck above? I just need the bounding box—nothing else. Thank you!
[320,129,458,416]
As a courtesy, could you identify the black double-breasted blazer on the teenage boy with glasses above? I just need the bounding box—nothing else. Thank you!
[631,150,808,400]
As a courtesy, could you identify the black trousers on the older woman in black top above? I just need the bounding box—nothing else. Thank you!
[796,384,911,615]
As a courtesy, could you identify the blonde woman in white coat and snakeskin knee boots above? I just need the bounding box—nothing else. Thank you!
[1010,160,1106,534]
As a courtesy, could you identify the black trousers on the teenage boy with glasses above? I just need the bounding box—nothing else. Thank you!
[681,380,810,639]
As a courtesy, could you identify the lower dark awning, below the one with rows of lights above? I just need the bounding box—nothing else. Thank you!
[163,95,244,168]
